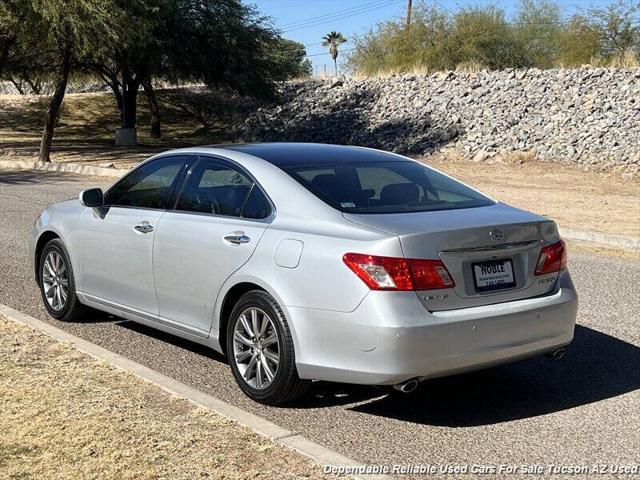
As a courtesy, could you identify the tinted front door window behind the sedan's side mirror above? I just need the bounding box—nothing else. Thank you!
[105,155,189,209]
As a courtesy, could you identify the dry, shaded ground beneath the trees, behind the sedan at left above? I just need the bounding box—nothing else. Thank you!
[0,87,246,168]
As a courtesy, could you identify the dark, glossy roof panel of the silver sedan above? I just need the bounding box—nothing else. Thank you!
[207,142,407,168]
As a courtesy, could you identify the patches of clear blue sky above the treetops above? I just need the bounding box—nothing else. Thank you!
[245,0,616,74]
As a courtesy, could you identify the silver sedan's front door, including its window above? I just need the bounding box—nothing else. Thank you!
[78,155,193,319]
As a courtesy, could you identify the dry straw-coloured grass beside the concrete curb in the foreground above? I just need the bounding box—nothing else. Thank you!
[0,317,327,480]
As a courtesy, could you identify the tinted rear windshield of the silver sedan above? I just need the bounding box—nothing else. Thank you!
[284,161,494,213]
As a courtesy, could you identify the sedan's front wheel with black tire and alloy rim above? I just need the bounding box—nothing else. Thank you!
[38,238,89,322]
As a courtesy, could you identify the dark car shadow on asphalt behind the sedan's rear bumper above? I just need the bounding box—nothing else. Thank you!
[351,325,640,427]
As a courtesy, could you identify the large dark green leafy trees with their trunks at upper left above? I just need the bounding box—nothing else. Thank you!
[0,0,311,162]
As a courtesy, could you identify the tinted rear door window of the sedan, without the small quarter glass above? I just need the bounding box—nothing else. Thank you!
[176,159,254,217]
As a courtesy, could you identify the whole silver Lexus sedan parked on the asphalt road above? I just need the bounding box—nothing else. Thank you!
[32,143,577,404]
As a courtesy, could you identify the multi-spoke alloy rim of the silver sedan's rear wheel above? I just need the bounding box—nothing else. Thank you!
[233,307,280,390]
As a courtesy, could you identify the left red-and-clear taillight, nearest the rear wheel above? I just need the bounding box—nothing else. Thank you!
[342,253,454,290]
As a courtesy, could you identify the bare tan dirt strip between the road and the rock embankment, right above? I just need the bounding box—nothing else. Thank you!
[424,158,640,237]
